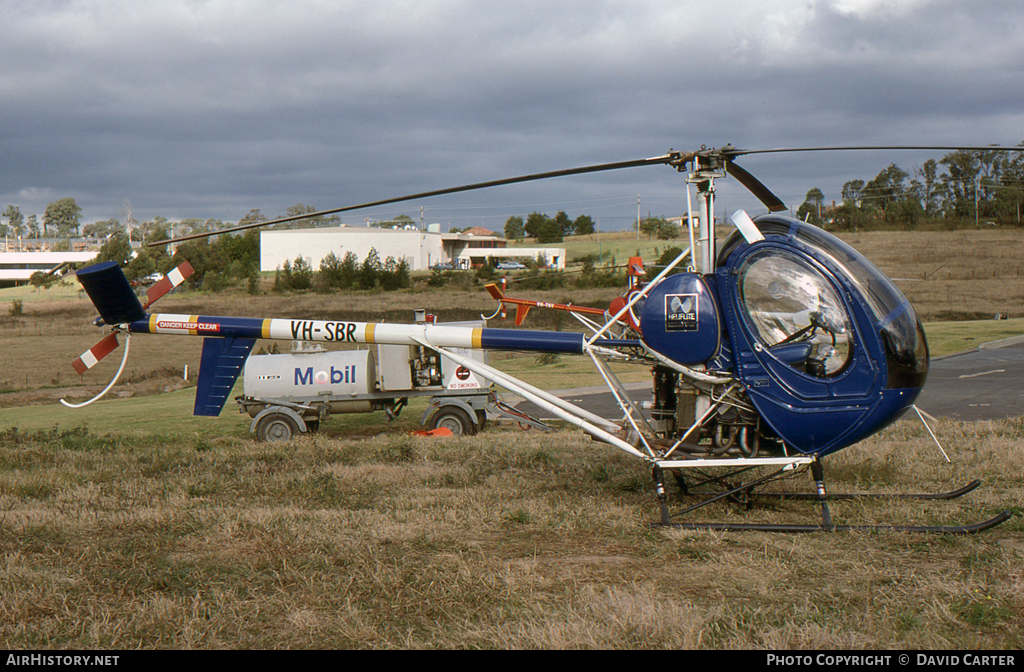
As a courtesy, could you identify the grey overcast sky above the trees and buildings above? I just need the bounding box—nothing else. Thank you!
[0,0,1024,230]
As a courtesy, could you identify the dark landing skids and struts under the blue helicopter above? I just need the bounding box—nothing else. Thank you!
[651,460,1013,535]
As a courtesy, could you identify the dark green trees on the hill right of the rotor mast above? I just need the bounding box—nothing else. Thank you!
[797,143,1024,229]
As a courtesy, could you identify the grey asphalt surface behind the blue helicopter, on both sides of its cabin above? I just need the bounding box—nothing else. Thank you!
[512,337,1024,420]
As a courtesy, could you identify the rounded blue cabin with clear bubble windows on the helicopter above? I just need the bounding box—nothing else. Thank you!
[716,215,928,455]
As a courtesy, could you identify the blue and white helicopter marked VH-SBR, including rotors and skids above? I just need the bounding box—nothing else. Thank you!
[69,145,1020,534]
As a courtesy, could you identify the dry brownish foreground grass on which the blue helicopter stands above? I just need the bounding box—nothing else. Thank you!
[0,422,1024,648]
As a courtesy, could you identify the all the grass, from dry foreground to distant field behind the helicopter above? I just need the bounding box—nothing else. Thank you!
[0,230,1024,649]
